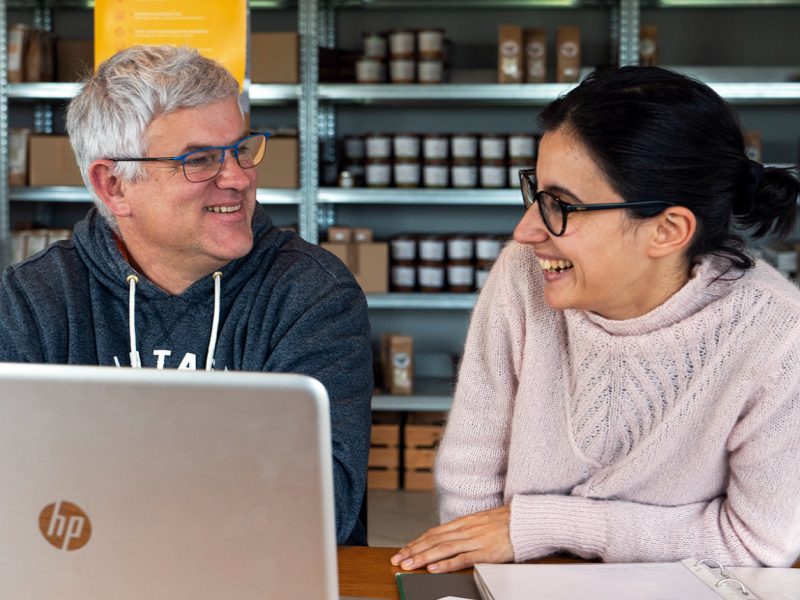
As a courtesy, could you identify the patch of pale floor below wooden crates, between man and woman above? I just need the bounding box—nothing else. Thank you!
[367,490,439,547]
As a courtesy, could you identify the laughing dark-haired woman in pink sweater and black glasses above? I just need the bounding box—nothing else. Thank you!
[392,67,800,572]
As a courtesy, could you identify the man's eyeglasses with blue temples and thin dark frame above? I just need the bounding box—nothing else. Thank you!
[108,133,270,183]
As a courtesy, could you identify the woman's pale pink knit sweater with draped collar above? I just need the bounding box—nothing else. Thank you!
[436,243,800,566]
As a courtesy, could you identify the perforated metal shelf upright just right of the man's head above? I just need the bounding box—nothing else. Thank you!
[298,0,319,244]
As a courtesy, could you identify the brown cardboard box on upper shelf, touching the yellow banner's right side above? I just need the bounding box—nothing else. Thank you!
[250,31,298,83]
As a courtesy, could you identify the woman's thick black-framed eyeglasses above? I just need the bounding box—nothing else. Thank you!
[519,169,675,237]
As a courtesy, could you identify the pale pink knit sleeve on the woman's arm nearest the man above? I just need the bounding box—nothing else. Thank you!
[436,246,522,522]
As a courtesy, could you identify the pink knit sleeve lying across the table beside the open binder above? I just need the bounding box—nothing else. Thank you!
[511,331,800,566]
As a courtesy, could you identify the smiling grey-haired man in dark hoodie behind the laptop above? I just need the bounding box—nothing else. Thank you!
[0,46,372,543]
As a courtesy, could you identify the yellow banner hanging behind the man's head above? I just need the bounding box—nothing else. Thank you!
[94,0,247,89]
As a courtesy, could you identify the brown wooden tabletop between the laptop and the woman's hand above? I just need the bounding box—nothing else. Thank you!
[337,546,800,600]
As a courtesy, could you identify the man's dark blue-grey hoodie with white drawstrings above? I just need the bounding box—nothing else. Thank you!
[0,206,373,543]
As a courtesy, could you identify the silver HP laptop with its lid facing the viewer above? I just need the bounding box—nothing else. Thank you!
[0,364,338,600]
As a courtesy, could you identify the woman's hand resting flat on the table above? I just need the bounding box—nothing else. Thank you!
[391,506,514,573]
